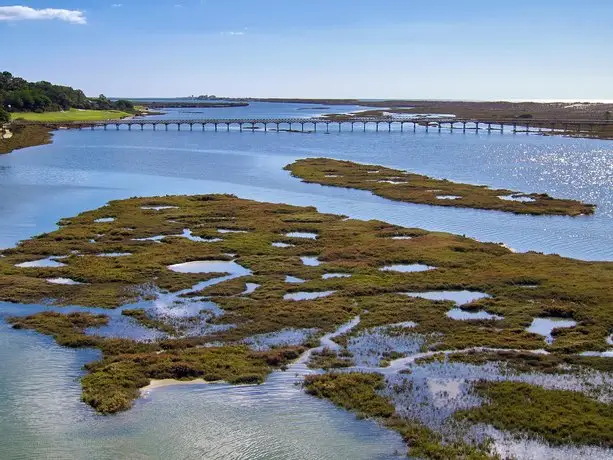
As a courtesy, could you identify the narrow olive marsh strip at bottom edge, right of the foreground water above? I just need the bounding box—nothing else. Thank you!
[304,372,496,460]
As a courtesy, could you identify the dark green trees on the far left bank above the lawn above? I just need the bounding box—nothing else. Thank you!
[0,72,134,117]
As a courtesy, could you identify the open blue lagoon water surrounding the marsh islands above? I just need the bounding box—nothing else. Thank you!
[0,104,613,459]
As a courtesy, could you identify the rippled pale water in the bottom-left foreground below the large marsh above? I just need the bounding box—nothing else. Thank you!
[0,305,406,460]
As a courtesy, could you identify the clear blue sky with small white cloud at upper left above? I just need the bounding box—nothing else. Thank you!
[0,0,613,101]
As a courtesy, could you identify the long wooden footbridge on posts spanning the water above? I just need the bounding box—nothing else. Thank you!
[29,116,613,133]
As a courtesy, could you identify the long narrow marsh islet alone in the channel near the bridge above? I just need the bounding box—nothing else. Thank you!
[285,158,595,216]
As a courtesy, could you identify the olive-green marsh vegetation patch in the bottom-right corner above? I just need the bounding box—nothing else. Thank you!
[456,382,613,448]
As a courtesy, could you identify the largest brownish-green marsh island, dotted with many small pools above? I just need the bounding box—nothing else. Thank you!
[0,195,613,430]
